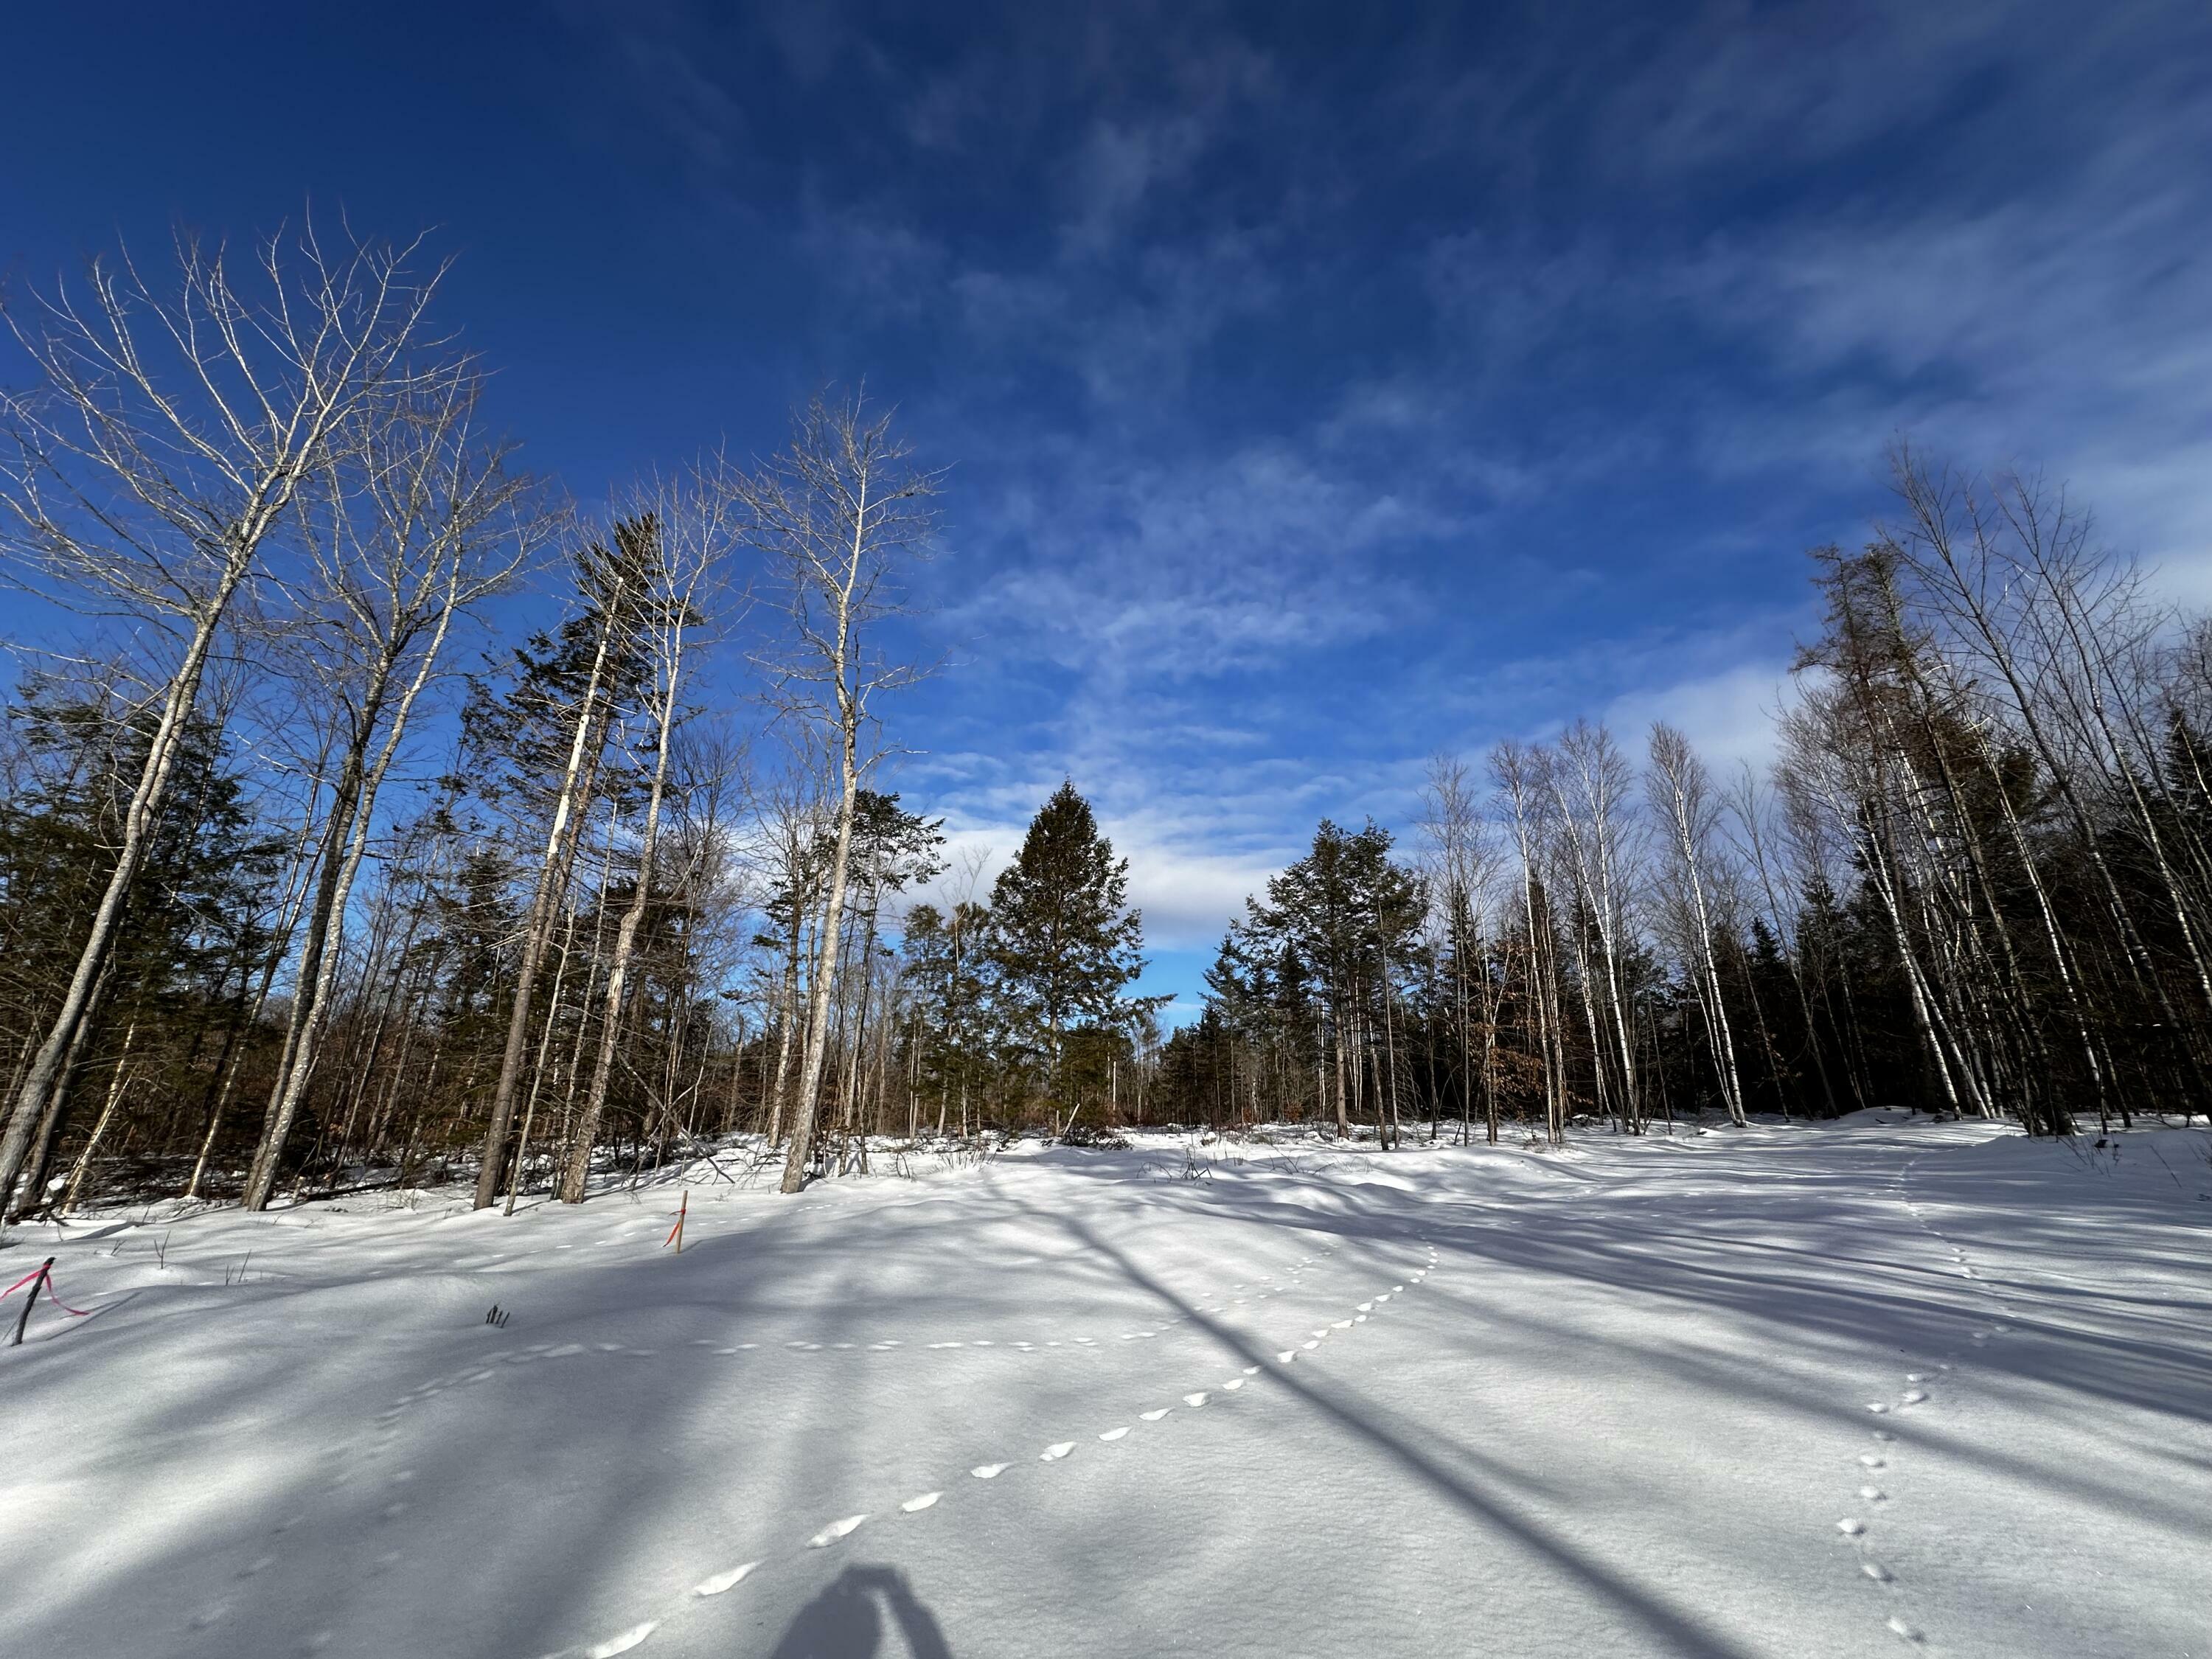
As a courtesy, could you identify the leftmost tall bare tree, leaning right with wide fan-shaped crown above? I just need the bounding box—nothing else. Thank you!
[0,226,438,1192]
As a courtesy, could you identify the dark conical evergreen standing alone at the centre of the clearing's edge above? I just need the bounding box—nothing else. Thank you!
[991,783,1144,1093]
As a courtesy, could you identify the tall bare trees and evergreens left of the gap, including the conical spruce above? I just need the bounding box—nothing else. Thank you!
[0,228,1152,1217]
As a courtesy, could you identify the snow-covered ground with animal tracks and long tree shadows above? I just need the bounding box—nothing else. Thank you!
[0,1115,2212,1659]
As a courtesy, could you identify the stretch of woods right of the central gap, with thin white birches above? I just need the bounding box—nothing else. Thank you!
[1155,458,2212,1141]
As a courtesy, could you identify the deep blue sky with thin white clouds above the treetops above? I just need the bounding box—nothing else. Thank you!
[0,0,2212,1022]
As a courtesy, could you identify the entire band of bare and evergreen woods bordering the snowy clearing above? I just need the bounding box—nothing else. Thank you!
[0,237,2212,1217]
